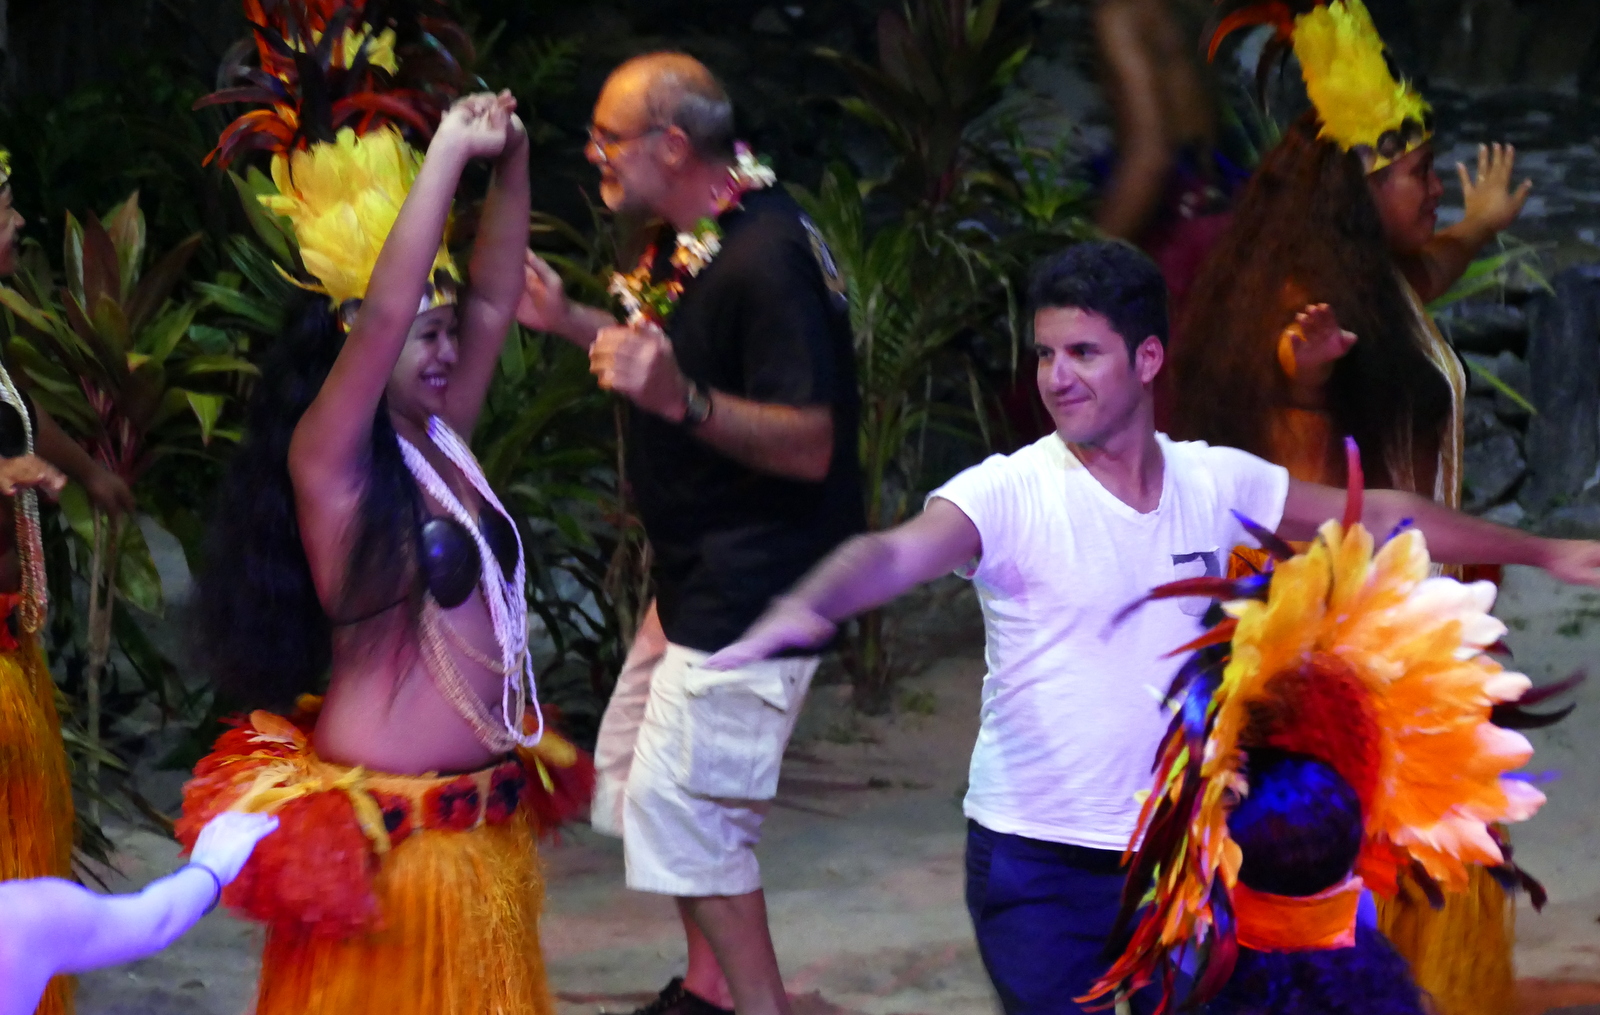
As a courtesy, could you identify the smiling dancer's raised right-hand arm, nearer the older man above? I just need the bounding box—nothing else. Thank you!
[446,91,528,434]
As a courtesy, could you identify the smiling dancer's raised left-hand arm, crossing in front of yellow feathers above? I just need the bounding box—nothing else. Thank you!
[290,96,506,488]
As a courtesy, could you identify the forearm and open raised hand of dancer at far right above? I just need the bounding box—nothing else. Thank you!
[1402,144,1533,303]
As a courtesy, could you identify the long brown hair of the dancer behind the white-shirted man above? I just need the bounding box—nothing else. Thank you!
[1171,114,1450,491]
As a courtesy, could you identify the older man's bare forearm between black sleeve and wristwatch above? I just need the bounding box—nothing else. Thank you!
[694,391,834,482]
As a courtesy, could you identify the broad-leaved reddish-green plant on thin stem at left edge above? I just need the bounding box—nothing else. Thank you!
[0,192,254,813]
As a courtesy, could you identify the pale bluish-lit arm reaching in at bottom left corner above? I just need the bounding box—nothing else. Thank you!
[0,813,278,1015]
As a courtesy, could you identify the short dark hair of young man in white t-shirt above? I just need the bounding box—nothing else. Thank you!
[1027,240,1168,359]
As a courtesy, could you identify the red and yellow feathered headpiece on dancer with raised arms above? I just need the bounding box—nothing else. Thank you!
[195,0,466,312]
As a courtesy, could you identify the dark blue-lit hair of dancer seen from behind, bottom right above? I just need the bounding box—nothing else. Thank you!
[1205,749,1424,1015]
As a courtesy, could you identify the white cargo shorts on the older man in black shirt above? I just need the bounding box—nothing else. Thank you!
[592,607,818,898]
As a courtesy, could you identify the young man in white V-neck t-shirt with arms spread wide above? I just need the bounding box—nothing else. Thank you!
[706,243,1600,1015]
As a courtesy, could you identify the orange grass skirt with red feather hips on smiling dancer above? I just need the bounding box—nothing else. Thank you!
[178,712,571,1015]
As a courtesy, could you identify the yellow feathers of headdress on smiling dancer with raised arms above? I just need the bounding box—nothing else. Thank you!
[259,126,461,314]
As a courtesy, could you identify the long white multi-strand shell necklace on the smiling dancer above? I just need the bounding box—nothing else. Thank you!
[395,416,544,751]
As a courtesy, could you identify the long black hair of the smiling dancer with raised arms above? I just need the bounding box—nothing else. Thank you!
[192,295,422,708]
